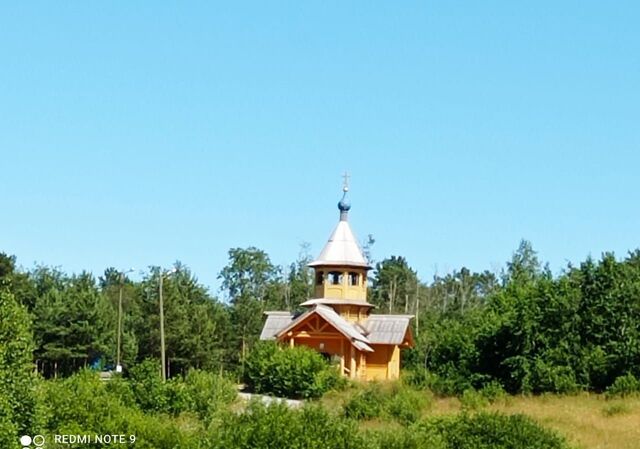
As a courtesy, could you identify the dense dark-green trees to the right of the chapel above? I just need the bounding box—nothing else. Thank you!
[409,242,640,393]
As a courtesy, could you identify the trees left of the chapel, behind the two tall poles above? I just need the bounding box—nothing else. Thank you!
[0,248,312,378]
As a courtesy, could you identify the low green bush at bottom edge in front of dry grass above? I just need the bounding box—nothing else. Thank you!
[423,413,568,449]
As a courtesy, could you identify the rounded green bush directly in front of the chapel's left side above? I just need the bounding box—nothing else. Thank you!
[244,342,343,399]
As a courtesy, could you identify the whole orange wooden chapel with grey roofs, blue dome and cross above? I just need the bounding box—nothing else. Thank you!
[260,174,413,380]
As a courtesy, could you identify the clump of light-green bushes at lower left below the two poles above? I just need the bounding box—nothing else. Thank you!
[35,362,236,449]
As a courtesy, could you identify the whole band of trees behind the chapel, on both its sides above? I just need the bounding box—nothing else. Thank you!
[0,241,640,393]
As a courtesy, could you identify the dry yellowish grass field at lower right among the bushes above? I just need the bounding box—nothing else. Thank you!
[323,384,640,449]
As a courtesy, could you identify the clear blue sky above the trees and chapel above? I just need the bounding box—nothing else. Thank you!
[0,0,640,292]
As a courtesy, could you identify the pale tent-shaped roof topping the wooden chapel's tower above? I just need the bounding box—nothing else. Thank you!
[309,218,369,268]
